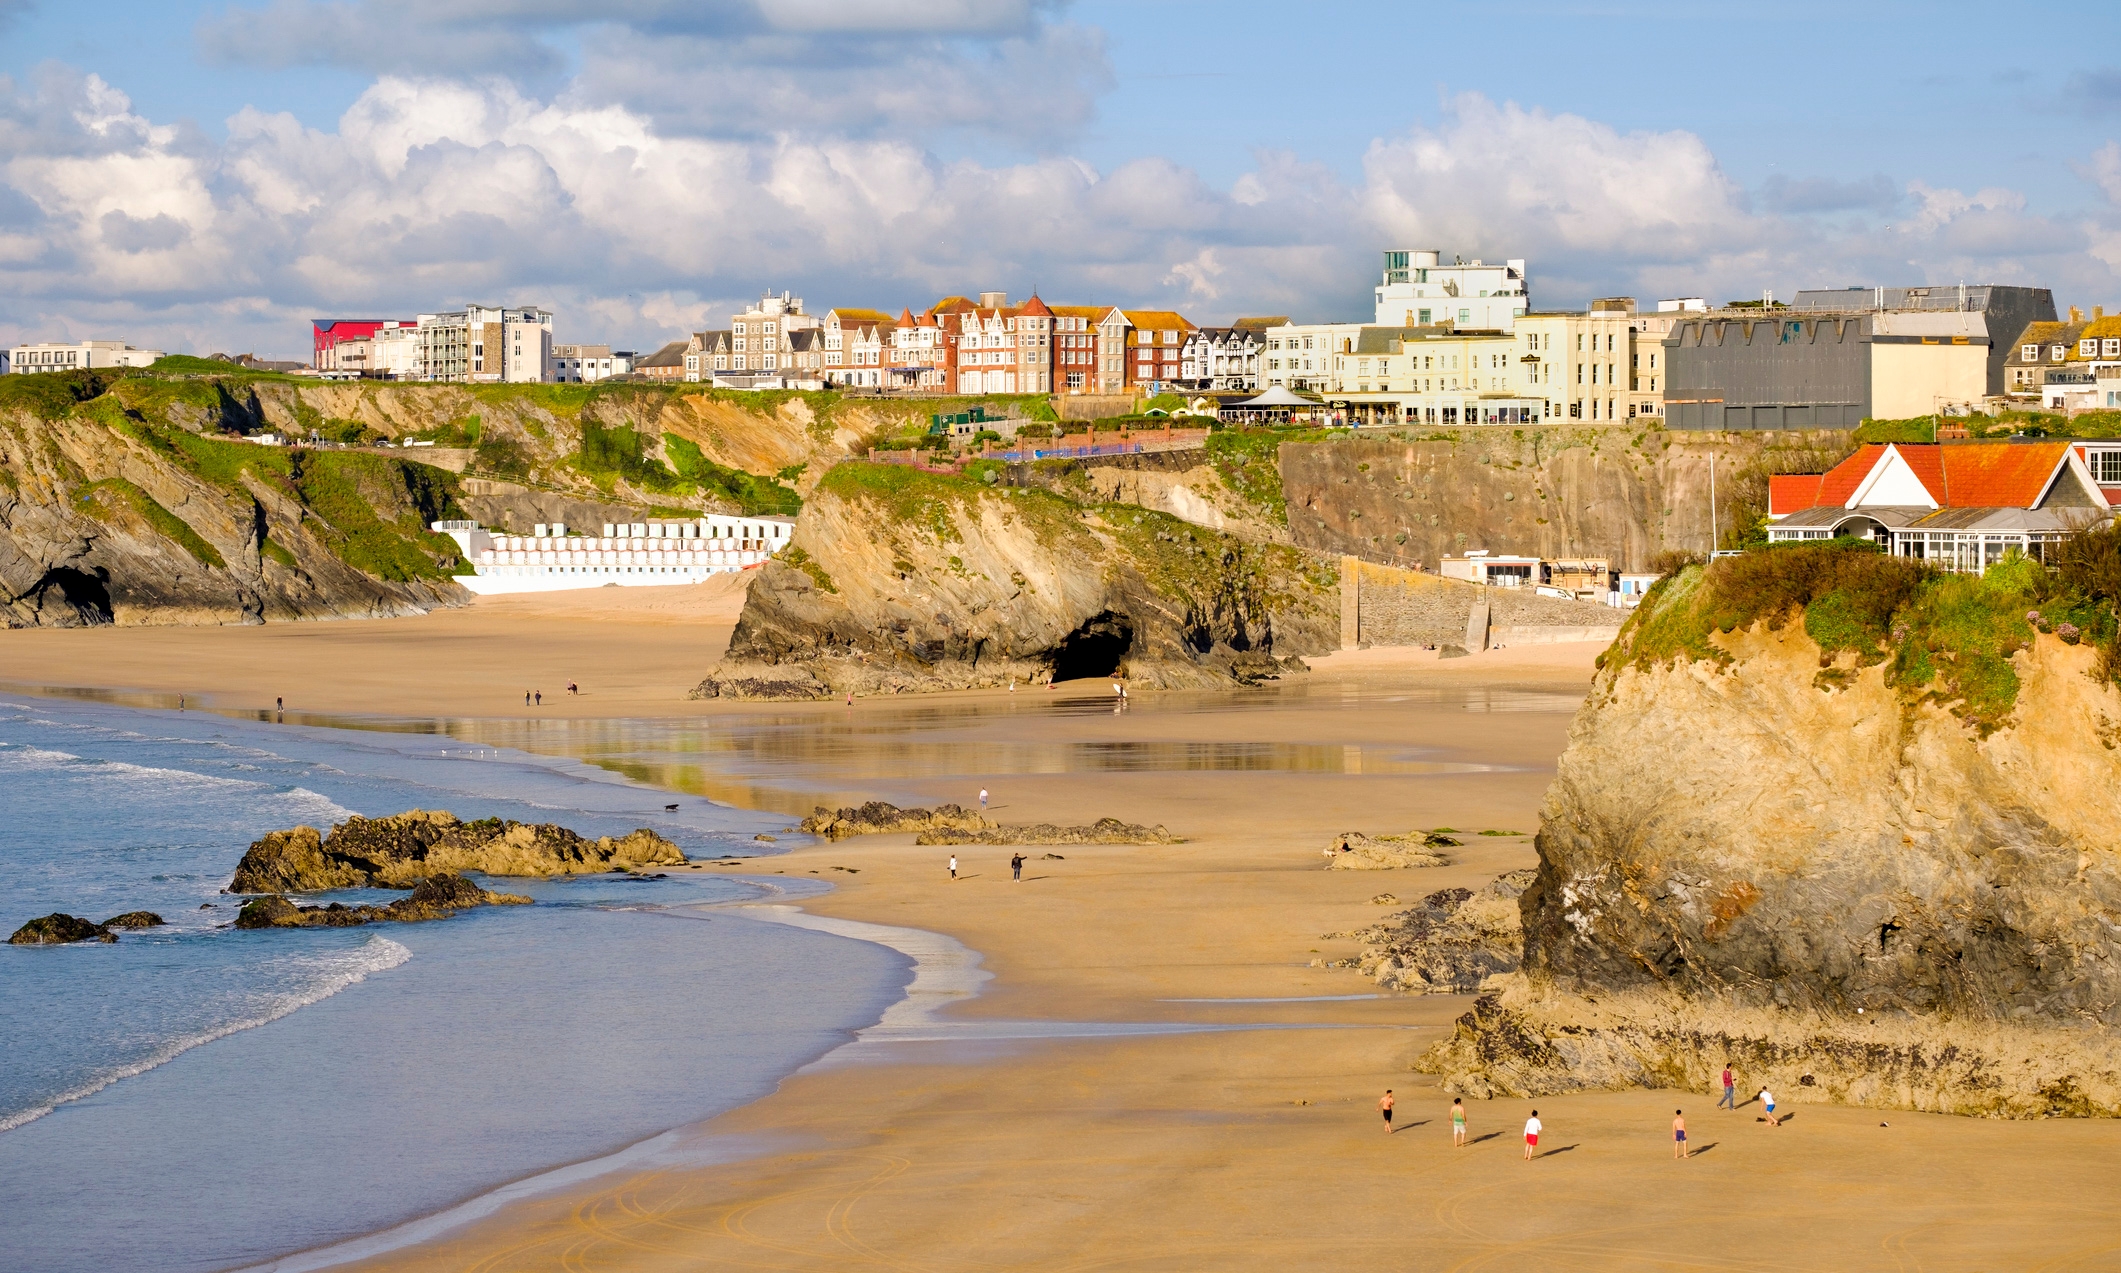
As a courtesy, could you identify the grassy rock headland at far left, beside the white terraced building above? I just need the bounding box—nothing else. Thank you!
[0,373,464,628]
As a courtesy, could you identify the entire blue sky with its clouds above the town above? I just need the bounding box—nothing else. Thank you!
[0,0,2121,359]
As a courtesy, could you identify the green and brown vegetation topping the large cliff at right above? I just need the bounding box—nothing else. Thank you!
[1599,530,2121,734]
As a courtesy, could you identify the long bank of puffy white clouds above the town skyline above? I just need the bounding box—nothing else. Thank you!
[0,70,2121,354]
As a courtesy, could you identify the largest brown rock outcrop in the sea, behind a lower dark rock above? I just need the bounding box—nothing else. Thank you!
[225,808,685,893]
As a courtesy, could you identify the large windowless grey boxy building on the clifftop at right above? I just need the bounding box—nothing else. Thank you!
[1663,284,2055,429]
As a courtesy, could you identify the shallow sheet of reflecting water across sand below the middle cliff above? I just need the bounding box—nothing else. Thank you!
[8,681,1582,815]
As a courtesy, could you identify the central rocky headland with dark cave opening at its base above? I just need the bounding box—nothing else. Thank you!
[694,463,1338,698]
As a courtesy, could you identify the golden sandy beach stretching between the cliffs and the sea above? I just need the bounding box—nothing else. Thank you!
[12,590,2121,1271]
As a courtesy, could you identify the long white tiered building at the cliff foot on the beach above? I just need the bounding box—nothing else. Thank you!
[435,513,795,596]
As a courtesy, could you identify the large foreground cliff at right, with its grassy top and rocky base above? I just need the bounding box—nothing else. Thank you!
[1427,535,2121,1116]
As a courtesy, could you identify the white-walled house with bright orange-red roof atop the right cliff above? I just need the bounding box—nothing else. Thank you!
[1767,439,2115,573]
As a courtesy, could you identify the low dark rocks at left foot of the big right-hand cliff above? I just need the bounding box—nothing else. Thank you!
[1338,870,1533,995]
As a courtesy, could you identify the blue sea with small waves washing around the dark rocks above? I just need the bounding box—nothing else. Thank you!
[0,698,910,1273]
